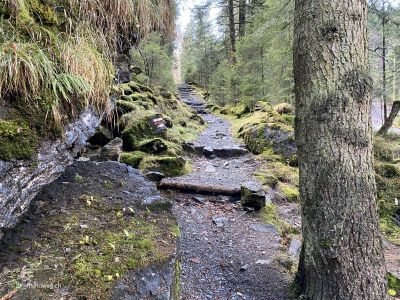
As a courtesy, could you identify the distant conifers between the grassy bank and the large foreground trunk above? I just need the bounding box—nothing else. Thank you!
[183,0,294,107]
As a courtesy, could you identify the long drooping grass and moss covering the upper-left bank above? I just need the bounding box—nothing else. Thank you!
[0,0,175,160]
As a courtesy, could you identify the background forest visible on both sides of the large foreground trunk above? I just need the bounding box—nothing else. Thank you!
[182,0,400,114]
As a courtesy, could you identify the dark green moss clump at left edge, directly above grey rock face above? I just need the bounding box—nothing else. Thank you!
[0,119,38,161]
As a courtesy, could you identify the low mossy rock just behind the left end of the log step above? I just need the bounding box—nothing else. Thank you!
[139,156,187,176]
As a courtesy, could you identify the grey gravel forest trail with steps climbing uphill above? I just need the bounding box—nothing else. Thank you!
[164,86,290,300]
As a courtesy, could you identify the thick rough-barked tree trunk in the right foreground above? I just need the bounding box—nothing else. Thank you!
[294,0,387,300]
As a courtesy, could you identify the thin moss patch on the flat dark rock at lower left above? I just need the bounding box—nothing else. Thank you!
[0,195,179,299]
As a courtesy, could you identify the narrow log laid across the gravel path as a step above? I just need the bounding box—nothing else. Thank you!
[158,180,241,196]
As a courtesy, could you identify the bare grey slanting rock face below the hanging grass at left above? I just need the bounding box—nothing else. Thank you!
[0,109,100,239]
